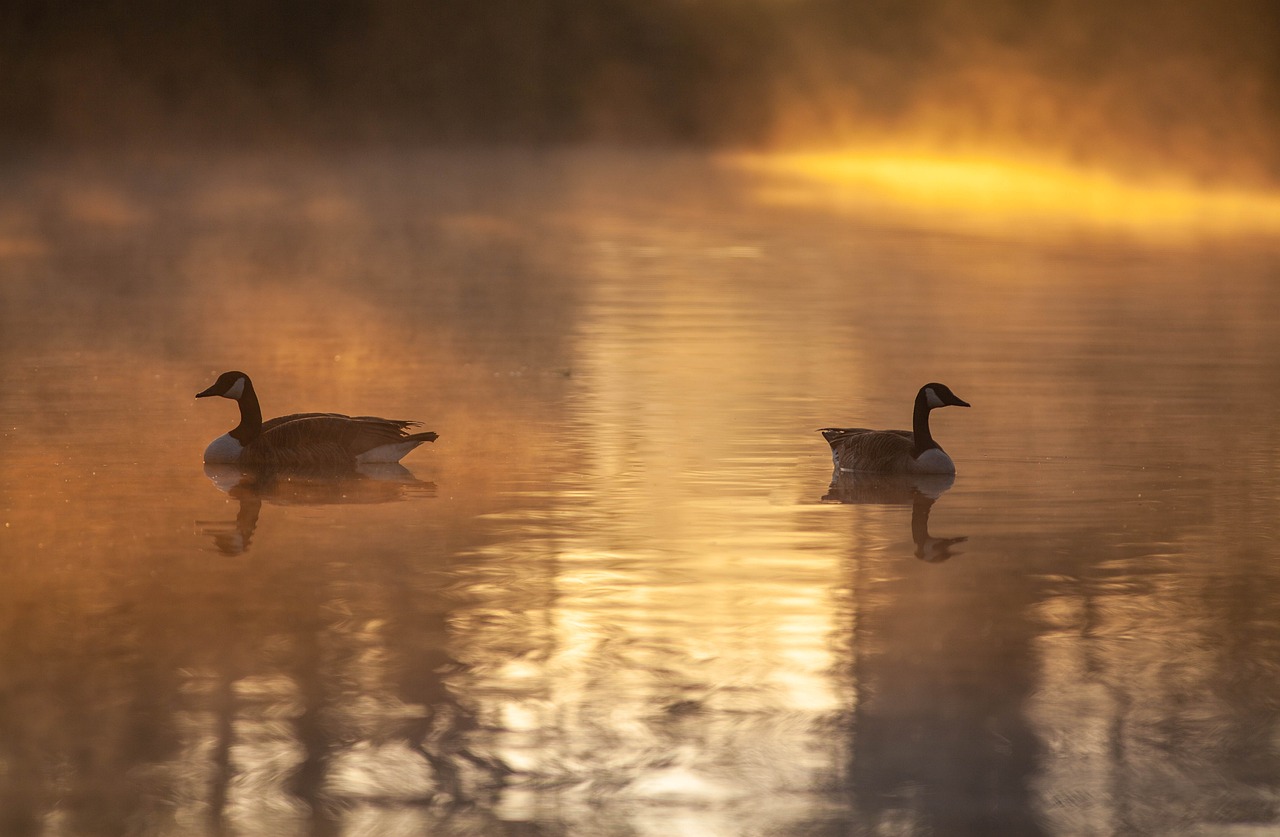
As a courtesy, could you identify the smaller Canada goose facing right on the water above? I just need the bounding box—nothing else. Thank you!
[818,384,969,474]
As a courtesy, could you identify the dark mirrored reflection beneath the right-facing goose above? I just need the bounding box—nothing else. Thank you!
[822,470,969,563]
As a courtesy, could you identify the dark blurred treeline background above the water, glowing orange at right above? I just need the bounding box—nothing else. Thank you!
[0,0,1280,177]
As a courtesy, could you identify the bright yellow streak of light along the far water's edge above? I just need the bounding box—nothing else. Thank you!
[731,150,1280,234]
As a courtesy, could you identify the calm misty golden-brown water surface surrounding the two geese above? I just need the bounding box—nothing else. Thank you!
[0,152,1280,837]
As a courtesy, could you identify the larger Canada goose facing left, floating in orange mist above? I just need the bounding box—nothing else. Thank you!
[196,371,436,468]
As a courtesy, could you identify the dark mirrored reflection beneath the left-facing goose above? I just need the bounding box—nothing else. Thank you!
[196,462,435,555]
